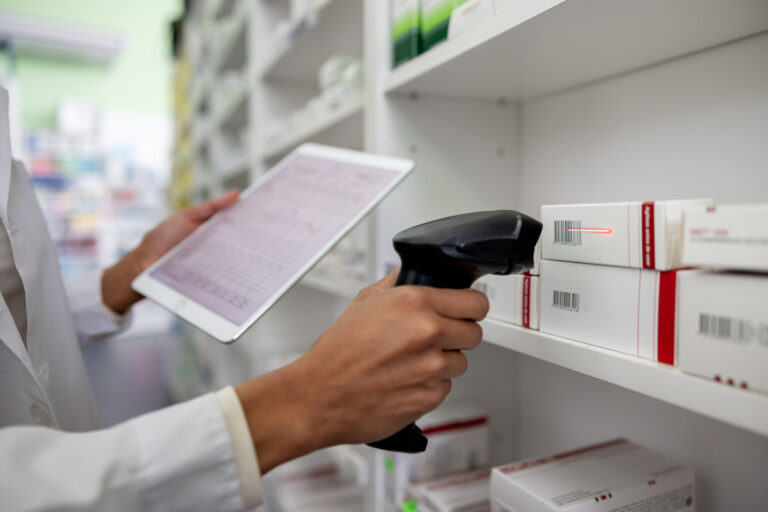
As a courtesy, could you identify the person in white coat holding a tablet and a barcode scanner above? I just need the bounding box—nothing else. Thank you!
[0,89,488,512]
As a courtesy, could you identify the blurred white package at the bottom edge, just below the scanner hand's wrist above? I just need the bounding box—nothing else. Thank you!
[265,448,365,512]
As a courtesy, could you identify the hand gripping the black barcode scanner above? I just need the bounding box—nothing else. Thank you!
[237,273,488,473]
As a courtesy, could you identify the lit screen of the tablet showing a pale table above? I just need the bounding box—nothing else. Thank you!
[151,155,398,325]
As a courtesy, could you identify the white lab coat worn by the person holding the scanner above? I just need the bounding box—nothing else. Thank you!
[0,88,258,511]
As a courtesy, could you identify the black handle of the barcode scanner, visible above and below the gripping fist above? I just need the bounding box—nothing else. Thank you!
[368,265,475,453]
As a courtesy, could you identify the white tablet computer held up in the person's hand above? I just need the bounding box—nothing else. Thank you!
[133,144,413,343]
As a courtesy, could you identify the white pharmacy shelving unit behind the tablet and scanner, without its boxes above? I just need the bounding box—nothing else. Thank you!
[171,0,768,512]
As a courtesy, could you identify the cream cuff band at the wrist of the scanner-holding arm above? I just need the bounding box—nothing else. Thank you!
[216,386,263,510]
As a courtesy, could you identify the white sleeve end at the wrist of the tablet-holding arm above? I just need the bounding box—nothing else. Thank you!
[66,270,133,347]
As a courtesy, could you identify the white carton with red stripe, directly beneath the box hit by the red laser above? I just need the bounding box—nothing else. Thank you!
[539,260,681,364]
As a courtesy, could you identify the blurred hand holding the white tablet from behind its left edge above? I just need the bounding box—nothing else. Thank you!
[101,190,240,314]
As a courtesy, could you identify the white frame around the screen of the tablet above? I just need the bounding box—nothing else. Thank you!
[132,143,414,343]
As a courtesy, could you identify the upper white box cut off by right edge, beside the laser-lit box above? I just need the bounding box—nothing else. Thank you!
[683,203,768,272]
